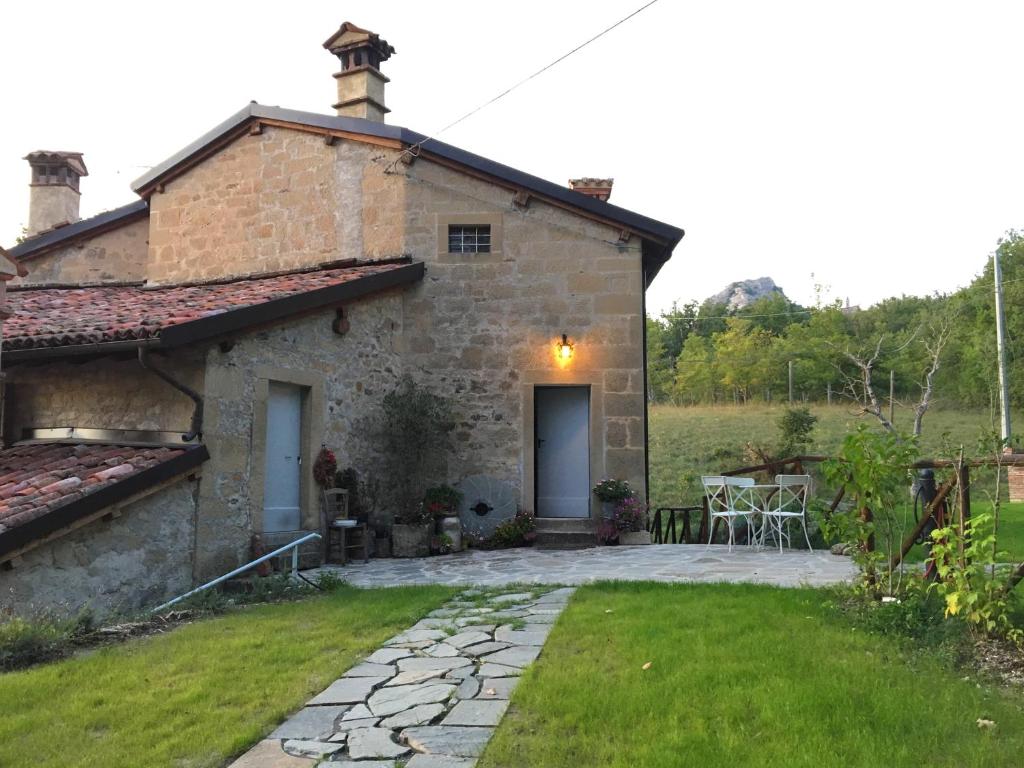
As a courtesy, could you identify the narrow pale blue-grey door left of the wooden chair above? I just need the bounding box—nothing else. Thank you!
[263,381,302,530]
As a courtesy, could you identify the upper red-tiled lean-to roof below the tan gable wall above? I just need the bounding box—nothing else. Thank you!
[3,262,411,350]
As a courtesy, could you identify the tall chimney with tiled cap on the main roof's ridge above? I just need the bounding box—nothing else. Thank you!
[324,22,394,123]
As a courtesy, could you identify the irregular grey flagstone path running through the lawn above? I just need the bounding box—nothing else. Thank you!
[230,587,573,768]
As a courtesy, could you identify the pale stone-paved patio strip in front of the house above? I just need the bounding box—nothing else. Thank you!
[309,544,856,587]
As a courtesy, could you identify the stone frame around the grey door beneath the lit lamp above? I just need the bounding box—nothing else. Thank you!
[520,370,604,524]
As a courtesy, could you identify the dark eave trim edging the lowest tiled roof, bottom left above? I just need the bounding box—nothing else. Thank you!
[0,445,210,559]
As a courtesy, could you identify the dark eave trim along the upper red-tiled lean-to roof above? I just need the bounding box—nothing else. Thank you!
[160,262,424,349]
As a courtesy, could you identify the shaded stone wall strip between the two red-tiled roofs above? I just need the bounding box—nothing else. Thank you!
[4,352,203,440]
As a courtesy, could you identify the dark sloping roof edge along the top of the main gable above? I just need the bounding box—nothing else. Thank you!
[132,102,684,253]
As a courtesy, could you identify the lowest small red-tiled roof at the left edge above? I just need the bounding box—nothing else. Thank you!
[0,443,187,536]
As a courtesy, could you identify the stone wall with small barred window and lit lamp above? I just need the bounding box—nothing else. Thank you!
[402,161,645,511]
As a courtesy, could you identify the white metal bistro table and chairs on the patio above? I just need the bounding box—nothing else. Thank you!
[700,475,812,552]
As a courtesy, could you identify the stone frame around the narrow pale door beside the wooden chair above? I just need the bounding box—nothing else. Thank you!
[249,367,326,534]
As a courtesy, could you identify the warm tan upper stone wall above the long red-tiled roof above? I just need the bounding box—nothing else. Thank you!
[147,127,402,283]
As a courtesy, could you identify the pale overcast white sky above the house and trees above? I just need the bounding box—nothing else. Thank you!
[0,0,1024,310]
